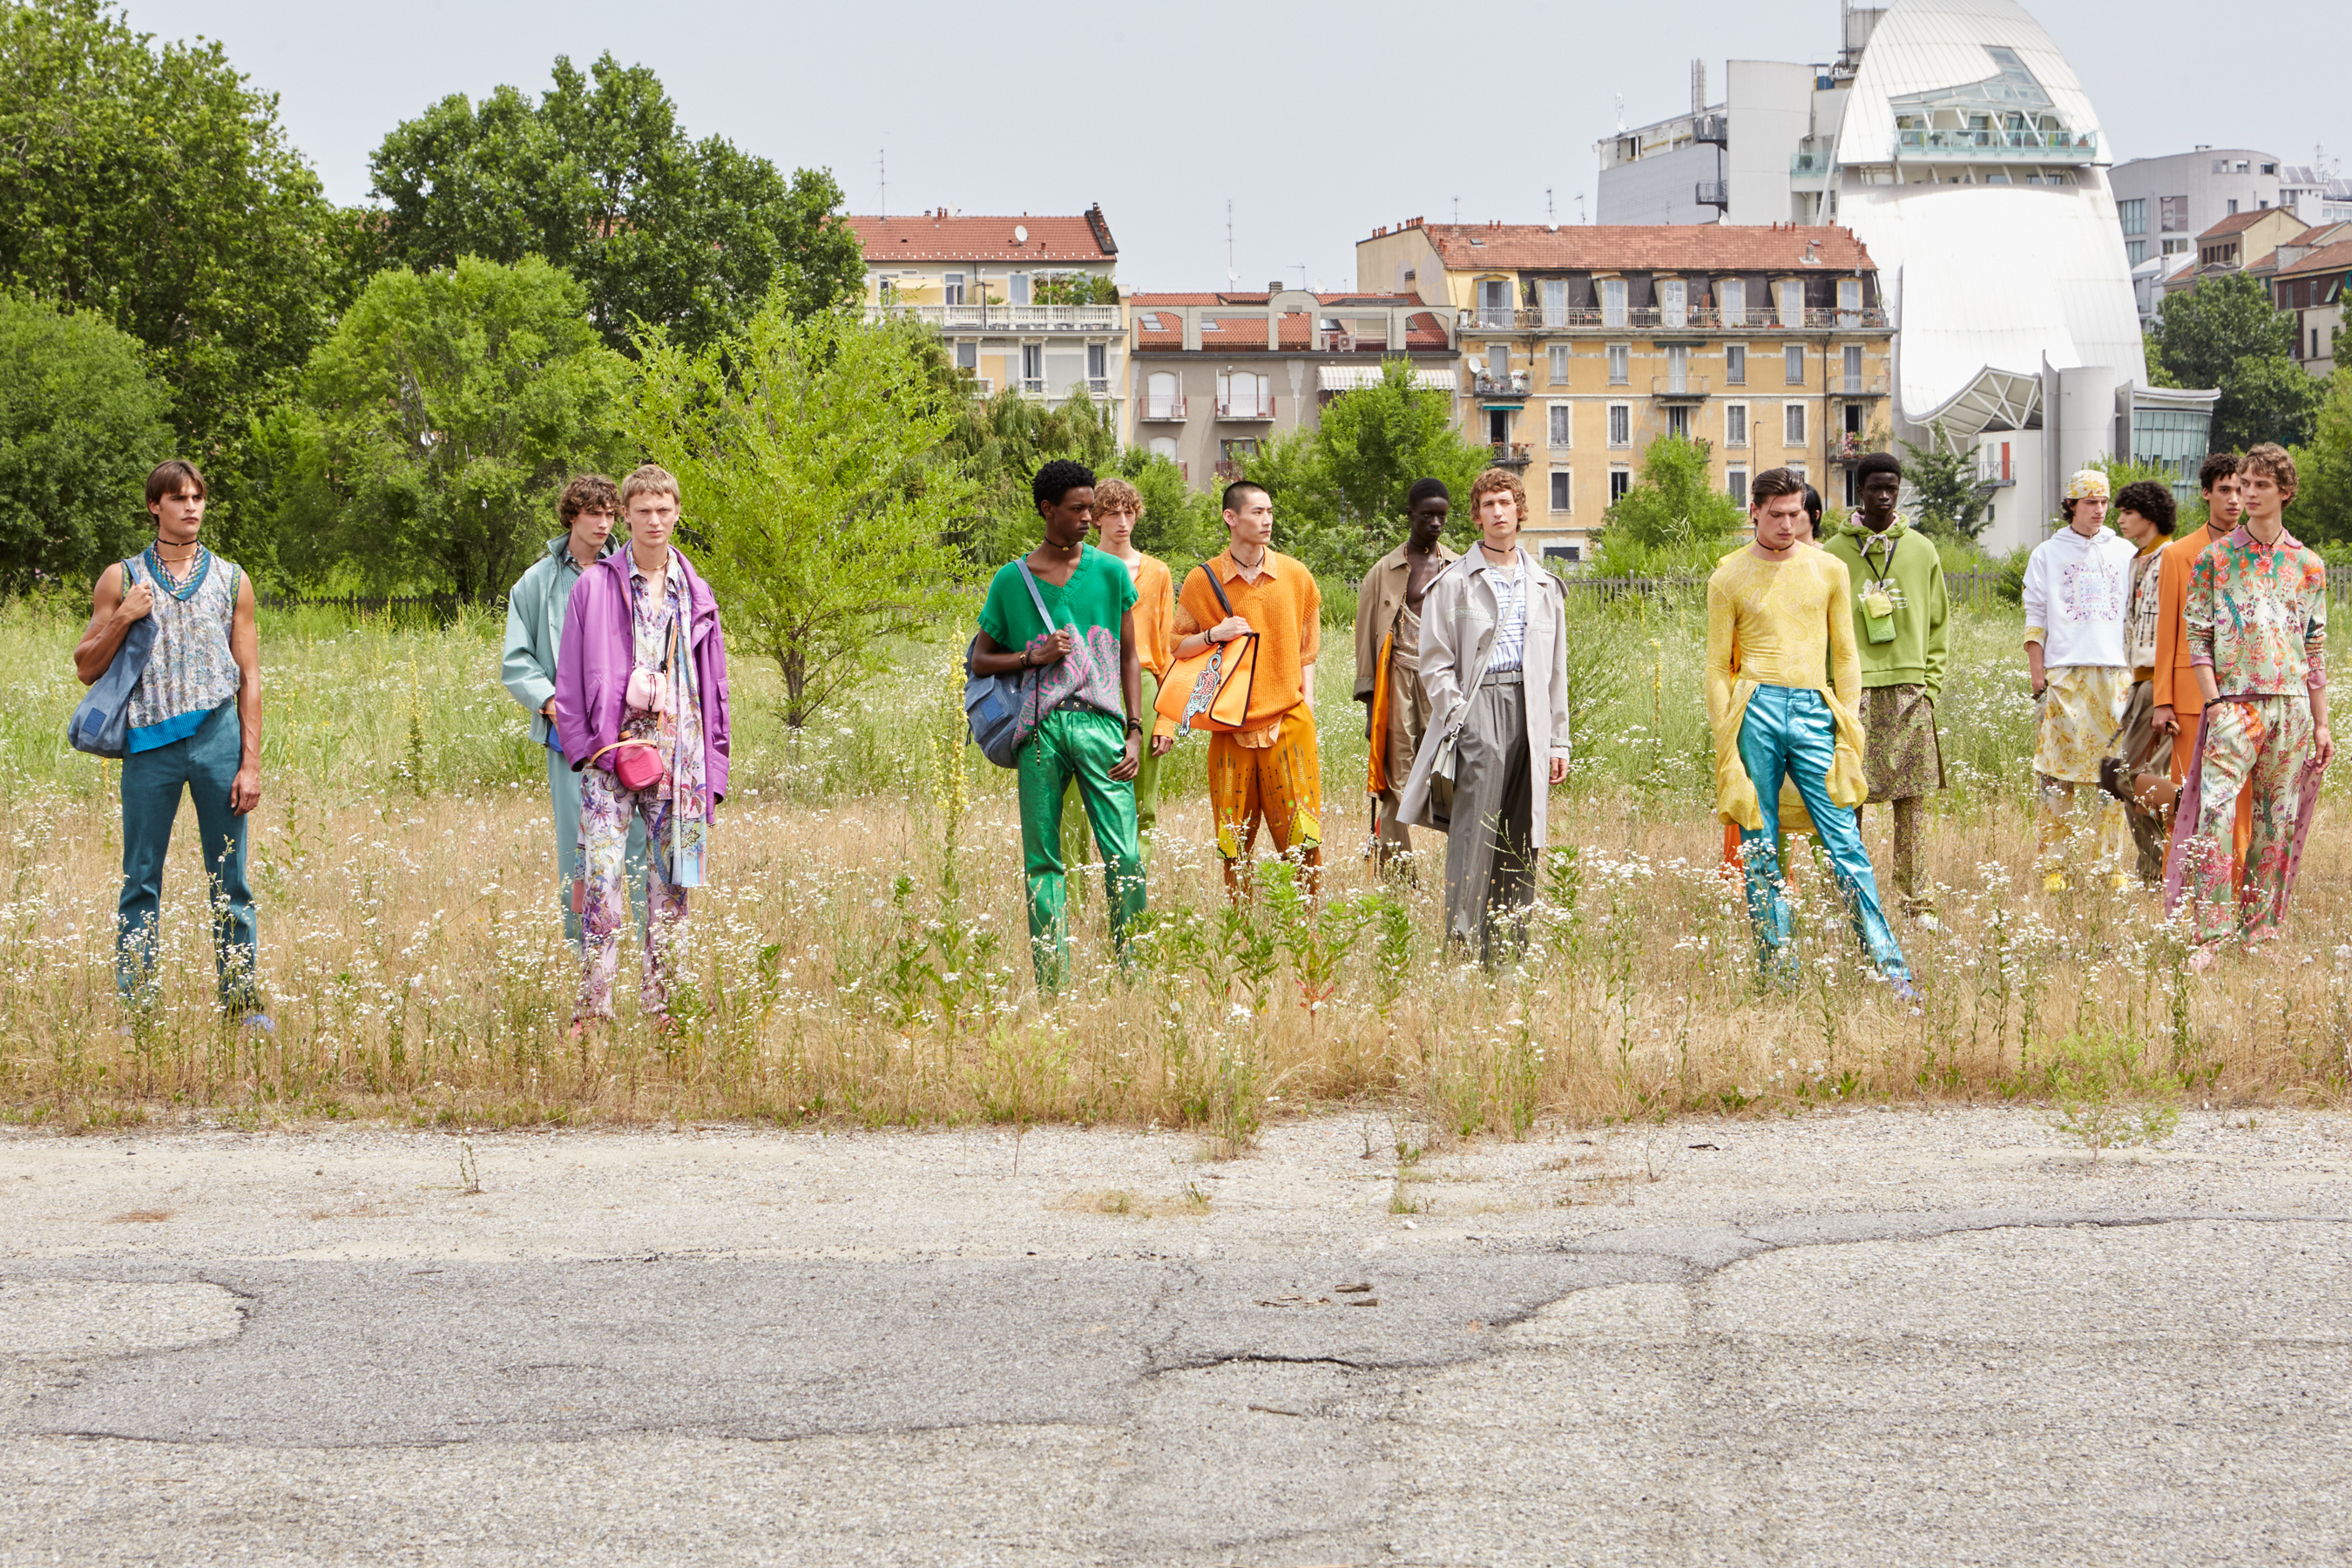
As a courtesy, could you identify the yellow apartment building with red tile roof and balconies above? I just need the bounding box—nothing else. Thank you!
[1355,219,1894,562]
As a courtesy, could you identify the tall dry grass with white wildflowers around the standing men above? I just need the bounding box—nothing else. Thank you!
[0,597,2352,1145]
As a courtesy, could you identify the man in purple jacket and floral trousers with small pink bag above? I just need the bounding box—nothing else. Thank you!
[555,463,727,1037]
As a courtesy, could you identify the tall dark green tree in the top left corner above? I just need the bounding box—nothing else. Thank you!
[0,0,353,529]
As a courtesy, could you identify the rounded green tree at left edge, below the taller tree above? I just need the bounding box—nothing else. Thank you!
[0,296,172,592]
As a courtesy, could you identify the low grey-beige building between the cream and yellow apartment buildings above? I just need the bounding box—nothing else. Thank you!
[1126,282,1454,489]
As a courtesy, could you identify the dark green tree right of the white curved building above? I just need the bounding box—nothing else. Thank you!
[2147,273,2326,451]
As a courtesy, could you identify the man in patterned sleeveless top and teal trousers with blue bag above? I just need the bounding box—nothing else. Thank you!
[73,458,273,1030]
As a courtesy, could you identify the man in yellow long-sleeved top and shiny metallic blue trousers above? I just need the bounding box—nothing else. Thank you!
[1707,468,1915,999]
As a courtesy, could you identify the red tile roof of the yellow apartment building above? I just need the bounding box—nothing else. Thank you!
[1390,223,1877,273]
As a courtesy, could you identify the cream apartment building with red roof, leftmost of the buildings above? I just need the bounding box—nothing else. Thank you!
[849,205,1126,416]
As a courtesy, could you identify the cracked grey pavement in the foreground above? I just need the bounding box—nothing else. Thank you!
[0,1110,2352,1565]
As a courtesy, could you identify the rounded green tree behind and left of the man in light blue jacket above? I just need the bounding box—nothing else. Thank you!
[259,256,628,599]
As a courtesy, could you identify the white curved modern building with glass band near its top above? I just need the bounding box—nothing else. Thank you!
[1599,0,2213,548]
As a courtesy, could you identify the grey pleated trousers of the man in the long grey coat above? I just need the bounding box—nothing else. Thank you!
[1447,670,1536,963]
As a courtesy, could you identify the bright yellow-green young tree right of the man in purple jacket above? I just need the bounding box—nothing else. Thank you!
[628,310,977,731]
